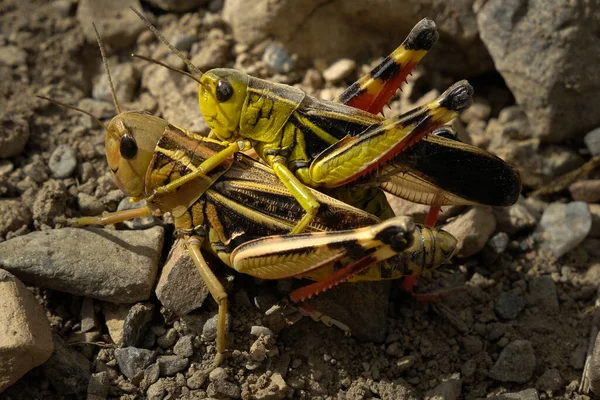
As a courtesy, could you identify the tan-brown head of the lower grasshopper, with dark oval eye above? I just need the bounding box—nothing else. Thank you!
[106,111,168,197]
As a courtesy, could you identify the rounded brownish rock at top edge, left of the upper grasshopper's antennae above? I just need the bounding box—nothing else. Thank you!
[77,0,146,50]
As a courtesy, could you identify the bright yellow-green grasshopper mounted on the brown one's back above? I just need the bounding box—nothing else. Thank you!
[132,7,488,233]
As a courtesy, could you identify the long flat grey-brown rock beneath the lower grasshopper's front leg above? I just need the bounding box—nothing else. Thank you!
[0,227,164,303]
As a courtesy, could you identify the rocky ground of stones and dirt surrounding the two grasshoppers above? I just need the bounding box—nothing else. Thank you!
[0,0,600,399]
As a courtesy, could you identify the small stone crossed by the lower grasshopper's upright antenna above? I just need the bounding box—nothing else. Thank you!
[92,62,140,104]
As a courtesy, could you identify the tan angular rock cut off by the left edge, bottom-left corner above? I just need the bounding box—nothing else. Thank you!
[0,269,54,393]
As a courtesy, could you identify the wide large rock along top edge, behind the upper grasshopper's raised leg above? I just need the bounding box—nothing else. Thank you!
[223,0,492,77]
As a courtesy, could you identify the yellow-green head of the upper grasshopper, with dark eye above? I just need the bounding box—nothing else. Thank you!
[198,68,248,140]
